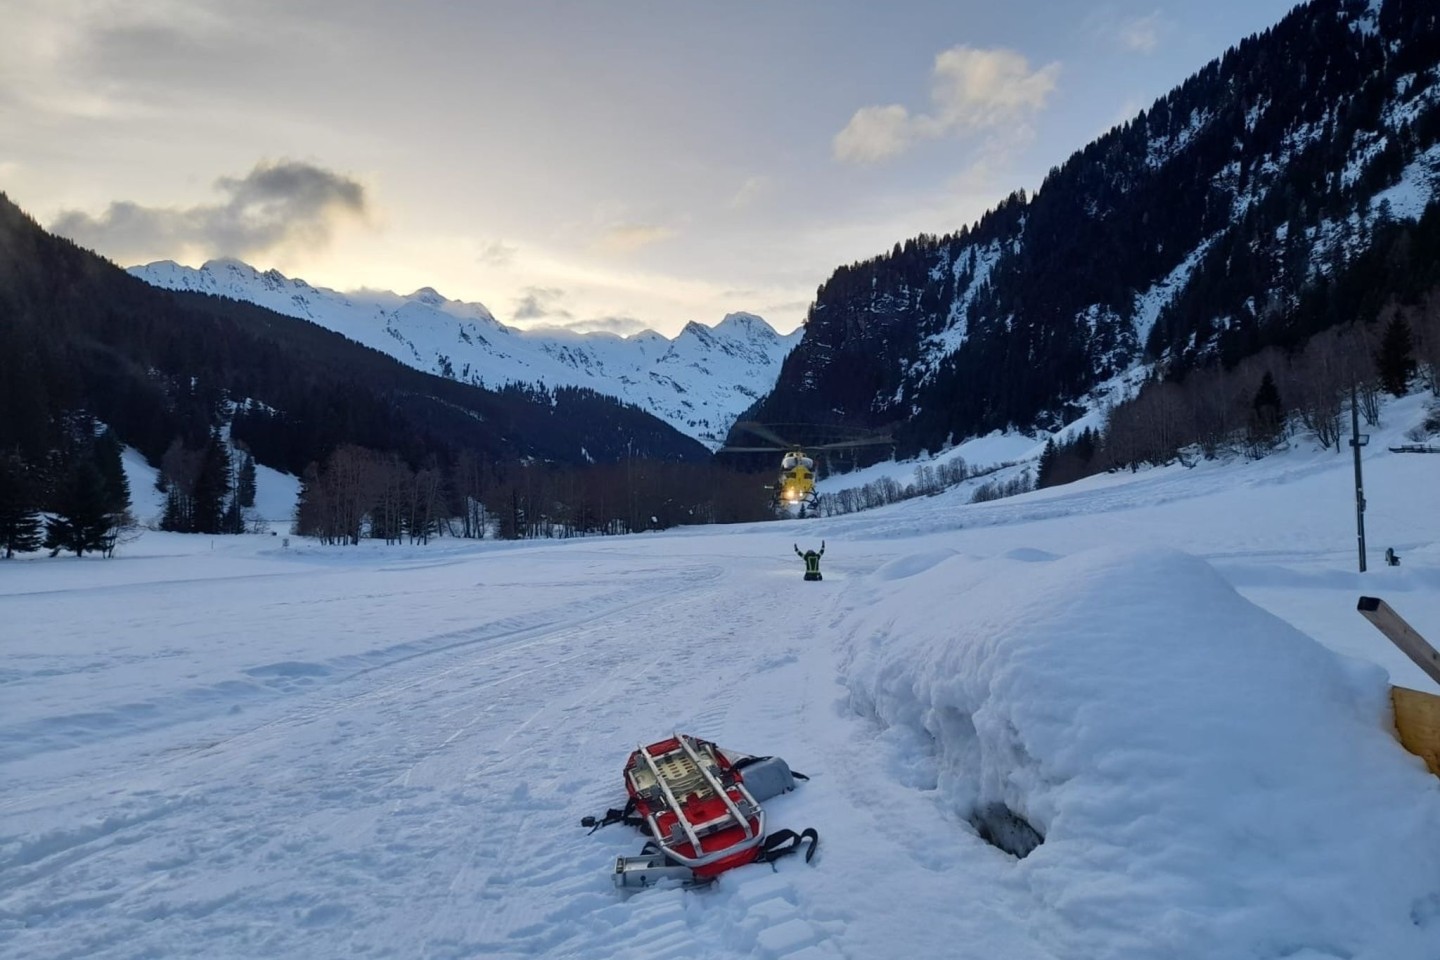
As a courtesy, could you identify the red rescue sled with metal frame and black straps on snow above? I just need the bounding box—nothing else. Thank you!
[580,733,819,887]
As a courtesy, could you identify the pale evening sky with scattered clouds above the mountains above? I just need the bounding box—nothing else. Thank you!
[0,0,1293,334]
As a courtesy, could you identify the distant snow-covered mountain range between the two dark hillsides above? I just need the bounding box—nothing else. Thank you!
[130,259,801,449]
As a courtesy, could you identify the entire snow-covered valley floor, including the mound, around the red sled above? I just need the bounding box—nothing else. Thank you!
[0,402,1440,960]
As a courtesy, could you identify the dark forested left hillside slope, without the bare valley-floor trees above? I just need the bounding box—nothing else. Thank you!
[0,189,708,552]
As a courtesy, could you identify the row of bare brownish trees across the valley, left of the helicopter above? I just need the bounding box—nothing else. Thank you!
[294,445,769,544]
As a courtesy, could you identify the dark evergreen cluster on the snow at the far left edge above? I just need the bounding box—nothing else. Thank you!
[0,415,134,560]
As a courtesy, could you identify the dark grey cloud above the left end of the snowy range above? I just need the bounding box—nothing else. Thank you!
[50,160,369,263]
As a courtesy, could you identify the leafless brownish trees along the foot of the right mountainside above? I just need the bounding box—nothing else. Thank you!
[1037,286,1440,486]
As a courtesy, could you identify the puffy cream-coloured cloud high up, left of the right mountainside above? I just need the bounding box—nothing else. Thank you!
[832,46,1060,164]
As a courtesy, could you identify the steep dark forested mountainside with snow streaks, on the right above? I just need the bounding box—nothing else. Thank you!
[746,0,1440,455]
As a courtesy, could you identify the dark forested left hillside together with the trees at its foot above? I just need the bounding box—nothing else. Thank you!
[0,196,777,553]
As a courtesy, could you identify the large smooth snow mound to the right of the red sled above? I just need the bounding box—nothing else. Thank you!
[842,548,1440,960]
